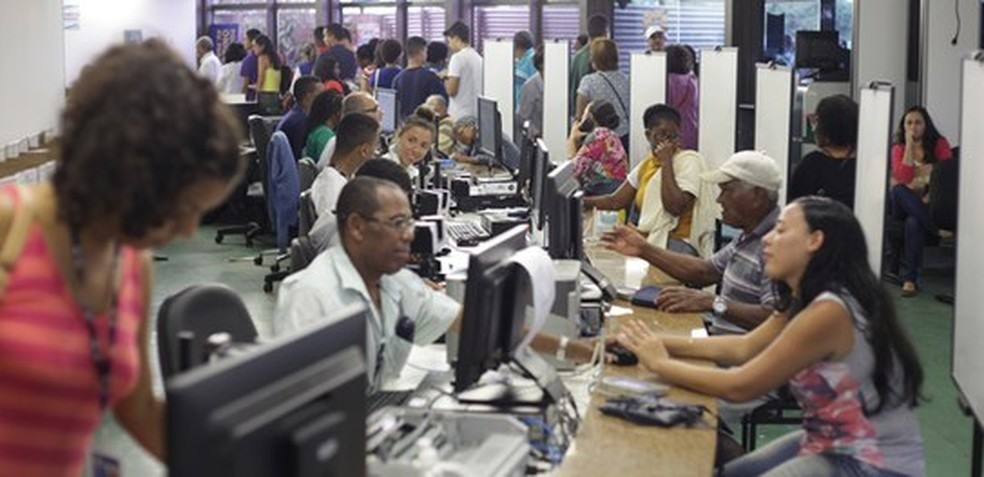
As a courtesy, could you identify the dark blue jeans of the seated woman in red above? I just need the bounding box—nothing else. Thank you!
[891,184,939,283]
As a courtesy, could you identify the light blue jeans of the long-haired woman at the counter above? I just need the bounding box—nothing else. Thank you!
[720,431,900,477]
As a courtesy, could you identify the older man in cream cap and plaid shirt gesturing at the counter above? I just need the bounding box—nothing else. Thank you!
[602,151,782,334]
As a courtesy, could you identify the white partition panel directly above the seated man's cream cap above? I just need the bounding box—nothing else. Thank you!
[697,48,738,169]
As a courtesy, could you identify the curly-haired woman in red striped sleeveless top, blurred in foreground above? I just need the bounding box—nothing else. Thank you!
[0,40,244,475]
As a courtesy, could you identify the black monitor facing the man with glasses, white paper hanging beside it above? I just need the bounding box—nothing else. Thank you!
[454,225,530,392]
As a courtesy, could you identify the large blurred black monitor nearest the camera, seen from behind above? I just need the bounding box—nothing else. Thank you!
[166,305,373,477]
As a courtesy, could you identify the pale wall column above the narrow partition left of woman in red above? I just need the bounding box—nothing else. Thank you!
[851,0,908,128]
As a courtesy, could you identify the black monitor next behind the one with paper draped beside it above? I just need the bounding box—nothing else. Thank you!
[543,161,584,260]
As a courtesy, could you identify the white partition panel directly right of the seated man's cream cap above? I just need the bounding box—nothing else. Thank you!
[756,63,793,204]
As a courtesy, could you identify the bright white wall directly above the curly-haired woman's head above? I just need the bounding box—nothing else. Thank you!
[63,0,196,86]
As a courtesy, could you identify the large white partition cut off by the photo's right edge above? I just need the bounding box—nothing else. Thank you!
[953,52,984,422]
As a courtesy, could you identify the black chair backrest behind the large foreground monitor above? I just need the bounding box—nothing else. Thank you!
[157,283,258,379]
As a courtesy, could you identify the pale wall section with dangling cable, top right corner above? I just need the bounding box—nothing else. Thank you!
[928,0,981,146]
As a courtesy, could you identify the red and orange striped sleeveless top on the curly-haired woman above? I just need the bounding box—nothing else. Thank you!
[0,189,145,476]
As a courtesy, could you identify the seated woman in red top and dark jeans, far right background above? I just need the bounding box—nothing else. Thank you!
[891,106,953,297]
